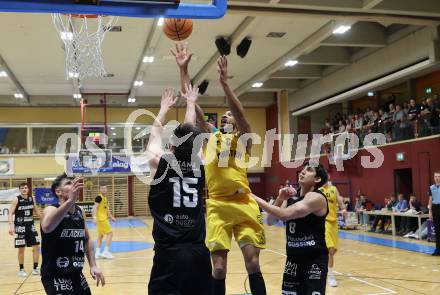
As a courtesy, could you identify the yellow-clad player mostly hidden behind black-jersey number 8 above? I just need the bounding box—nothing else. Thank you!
[320,174,347,287]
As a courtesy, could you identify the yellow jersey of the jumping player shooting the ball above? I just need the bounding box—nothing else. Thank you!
[205,131,251,198]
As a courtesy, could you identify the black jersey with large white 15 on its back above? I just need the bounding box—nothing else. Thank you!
[148,154,205,249]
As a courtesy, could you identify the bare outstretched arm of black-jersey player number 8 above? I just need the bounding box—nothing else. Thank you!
[253,192,326,221]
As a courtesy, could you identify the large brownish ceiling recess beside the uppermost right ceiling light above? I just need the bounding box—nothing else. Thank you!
[321,22,388,47]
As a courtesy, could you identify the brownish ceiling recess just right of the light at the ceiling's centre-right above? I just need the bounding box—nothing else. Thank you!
[298,47,351,66]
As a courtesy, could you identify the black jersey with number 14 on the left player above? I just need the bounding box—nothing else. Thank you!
[41,204,87,277]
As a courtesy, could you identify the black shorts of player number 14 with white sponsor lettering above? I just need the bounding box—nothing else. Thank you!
[41,273,92,295]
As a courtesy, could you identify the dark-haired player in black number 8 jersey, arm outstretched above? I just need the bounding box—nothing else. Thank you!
[255,164,328,295]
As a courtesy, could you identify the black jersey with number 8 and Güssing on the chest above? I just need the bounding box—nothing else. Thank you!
[286,190,328,256]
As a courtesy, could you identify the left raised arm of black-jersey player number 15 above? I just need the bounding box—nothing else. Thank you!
[147,88,177,177]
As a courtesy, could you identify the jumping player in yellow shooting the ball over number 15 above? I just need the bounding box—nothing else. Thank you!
[173,44,266,295]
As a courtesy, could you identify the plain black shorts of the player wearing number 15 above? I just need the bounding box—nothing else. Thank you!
[148,245,212,295]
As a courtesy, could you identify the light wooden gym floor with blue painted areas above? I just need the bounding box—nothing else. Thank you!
[0,219,440,295]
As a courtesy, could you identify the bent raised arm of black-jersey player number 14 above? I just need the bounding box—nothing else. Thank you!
[41,178,84,233]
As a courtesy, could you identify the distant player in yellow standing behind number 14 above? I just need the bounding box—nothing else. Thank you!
[93,185,116,259]
